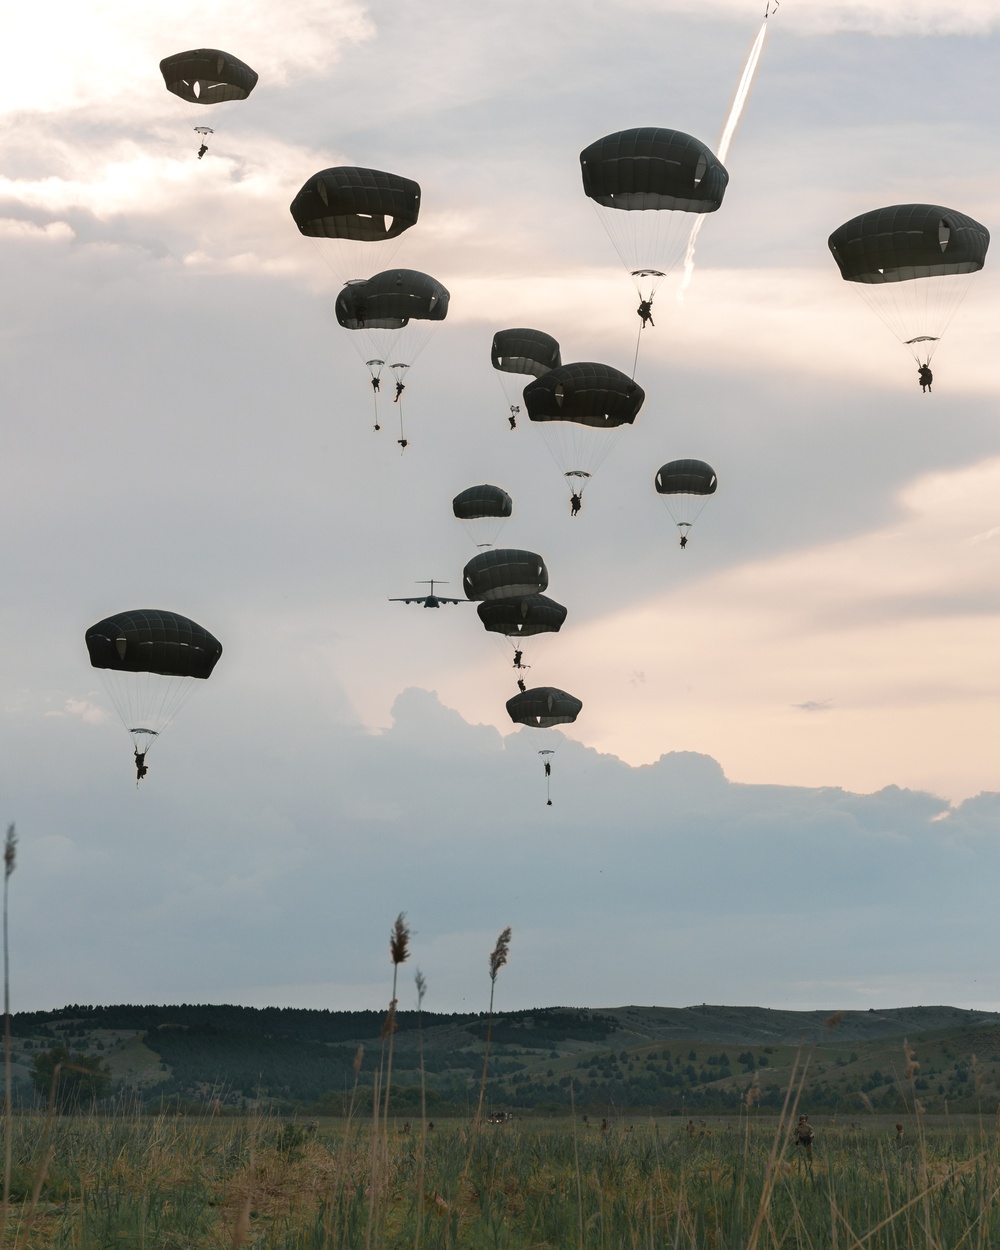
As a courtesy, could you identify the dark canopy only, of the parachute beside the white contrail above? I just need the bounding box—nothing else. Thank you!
[580,126,729,213]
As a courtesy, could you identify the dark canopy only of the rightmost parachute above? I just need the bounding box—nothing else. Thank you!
[829,204,990,286]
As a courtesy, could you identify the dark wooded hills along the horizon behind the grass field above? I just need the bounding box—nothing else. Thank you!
[13,1004,1000,1115]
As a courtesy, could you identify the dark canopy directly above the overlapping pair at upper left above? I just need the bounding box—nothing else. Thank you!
[291,165,420,243]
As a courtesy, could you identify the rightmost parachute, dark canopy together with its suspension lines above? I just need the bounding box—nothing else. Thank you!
[829,204,990,365]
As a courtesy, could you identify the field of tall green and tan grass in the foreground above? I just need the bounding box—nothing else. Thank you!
[4,1116,1000,1250]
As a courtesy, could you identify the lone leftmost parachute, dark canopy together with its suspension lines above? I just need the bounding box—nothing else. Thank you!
[86,609,223,751]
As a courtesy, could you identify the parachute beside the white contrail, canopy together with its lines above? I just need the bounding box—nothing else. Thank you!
[580,126,729,301]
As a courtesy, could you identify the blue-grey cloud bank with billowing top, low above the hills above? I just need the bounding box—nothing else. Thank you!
[7,678,1000,1010]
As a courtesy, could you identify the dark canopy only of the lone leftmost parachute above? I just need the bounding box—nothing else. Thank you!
[86,609,223,679]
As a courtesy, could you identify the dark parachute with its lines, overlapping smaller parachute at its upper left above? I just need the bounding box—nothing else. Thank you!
[524,363,646,498]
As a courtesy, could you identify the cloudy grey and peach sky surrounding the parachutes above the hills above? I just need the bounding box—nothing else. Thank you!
[0,0,1000,1010]
